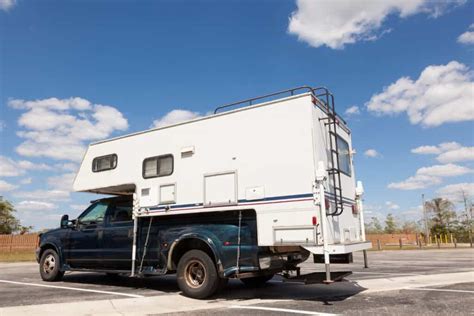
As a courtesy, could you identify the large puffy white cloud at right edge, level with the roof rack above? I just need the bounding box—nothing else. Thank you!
[366,61,474,127]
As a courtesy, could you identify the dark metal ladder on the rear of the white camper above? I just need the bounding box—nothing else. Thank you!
[314,88,344,216]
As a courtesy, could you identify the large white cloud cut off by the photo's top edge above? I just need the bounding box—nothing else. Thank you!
[288,0,466,49]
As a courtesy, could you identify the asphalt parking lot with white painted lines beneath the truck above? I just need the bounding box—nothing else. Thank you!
[0,249,474,315]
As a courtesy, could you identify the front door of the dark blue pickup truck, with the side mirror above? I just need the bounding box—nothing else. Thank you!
[66,201,109,269]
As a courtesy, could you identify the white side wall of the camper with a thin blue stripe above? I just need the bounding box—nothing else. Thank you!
[74,94,362,246]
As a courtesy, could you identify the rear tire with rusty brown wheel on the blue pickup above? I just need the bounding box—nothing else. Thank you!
[177,250,220,299]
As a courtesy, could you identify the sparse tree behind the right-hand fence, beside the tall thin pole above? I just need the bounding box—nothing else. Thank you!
[426,198,456,234]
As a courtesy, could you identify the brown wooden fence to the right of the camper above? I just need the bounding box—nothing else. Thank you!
[366,234,473,250]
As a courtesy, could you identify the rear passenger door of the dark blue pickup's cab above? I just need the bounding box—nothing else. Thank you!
[102,199,133,270]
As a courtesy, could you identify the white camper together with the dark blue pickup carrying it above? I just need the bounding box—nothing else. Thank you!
[37,86,370,298]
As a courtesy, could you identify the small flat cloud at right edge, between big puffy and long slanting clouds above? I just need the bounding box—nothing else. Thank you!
[411,142,474,163]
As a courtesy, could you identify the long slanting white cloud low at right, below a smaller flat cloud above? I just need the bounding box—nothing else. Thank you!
[388,164,473,190]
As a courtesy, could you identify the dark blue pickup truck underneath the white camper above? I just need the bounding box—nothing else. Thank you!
[36,196,309,298]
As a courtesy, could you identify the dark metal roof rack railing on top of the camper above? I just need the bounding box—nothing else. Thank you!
[214,86,346,124]
